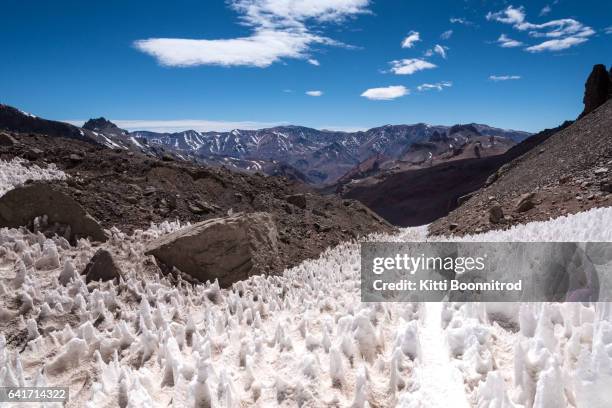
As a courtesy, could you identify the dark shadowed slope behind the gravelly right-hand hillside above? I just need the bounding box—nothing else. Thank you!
[335,127,561,226]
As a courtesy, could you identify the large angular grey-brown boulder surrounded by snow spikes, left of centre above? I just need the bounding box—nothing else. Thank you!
[146,212,278,287]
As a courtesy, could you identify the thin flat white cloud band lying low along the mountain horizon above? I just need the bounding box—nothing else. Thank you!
[66,119,287,133]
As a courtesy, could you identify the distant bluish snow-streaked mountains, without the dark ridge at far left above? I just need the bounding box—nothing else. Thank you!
[132,123,530,185]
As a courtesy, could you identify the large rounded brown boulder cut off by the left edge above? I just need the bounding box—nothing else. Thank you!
[0,183,107,242]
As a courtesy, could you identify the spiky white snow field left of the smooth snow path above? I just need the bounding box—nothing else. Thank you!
[0,224,438,407]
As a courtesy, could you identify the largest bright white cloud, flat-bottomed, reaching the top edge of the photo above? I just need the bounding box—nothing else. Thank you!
[134,0,370,67]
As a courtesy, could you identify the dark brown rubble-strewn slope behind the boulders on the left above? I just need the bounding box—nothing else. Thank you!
[0,133,393,270]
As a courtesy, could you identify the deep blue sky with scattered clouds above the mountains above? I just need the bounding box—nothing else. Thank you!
[0,0,612,131]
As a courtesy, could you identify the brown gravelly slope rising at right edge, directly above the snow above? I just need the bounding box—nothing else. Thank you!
[430,98,612,235]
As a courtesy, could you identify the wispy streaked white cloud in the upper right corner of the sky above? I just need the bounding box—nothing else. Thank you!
[486,6,595,52]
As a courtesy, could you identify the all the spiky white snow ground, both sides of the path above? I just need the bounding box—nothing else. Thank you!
[0,158,612,408]
